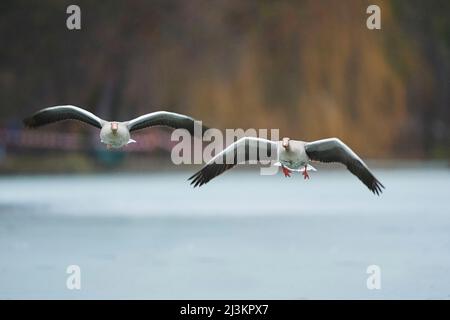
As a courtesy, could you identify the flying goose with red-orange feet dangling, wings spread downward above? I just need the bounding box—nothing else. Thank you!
[189,137,384,195]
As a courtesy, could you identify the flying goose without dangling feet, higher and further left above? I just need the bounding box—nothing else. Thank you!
[23,105,207,149]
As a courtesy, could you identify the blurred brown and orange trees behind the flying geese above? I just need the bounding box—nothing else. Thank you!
[0,0,450,172]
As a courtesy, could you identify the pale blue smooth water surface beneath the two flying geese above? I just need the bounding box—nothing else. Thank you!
[0,168,450,299]
